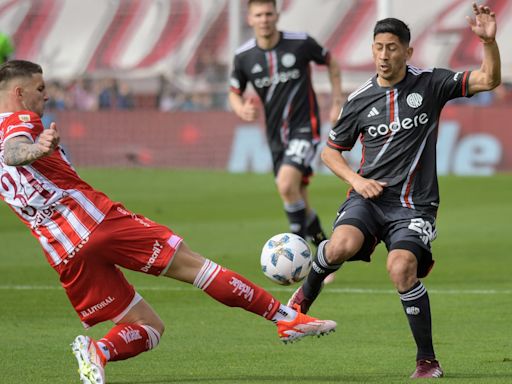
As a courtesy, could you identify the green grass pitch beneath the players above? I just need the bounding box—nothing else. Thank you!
[0,169,512,384]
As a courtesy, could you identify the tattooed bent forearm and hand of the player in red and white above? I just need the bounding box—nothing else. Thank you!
[4,123,60,166]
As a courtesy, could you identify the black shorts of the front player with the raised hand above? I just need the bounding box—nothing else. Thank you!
[333,193,437,277]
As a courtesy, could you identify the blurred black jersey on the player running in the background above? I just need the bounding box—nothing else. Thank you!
[230,32,330,151]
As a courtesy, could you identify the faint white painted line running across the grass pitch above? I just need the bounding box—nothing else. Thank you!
[0,285,512,295]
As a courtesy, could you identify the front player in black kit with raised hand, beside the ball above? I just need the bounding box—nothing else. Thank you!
[288,4,501,378]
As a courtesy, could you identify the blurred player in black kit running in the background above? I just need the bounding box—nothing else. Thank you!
[229,0,343,270]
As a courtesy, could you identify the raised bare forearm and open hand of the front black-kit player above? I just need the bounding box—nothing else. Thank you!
[466,3,501,94]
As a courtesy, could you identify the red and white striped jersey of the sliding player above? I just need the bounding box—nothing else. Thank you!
[0,111,113,266]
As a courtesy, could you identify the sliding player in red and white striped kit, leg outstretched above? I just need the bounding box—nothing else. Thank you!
[0,60,336,384]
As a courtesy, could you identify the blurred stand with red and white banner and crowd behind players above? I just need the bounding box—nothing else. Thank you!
[0,0,512,111]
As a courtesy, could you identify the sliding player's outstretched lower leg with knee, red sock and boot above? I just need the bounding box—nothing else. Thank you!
[165,242,336,342]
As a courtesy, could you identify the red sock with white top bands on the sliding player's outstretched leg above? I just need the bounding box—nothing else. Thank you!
[194,260,280,320]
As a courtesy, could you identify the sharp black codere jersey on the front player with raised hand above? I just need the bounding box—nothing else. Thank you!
[327,66,470,208]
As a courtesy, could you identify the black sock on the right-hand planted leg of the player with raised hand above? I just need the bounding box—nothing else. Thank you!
[399,281,435,360]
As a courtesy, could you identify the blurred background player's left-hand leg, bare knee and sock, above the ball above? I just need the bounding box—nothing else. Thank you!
[276,164,307,238]
